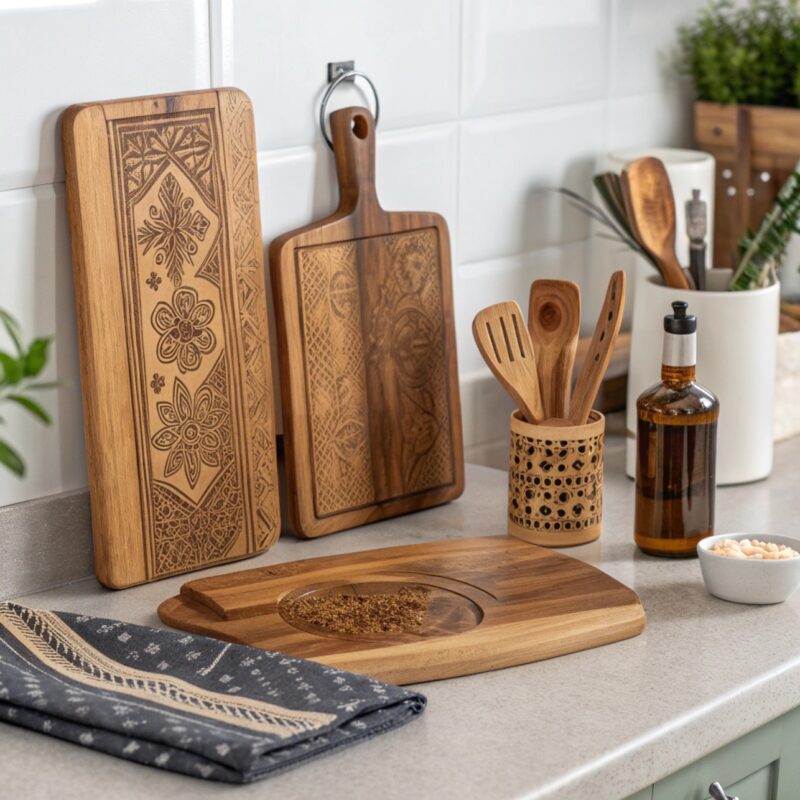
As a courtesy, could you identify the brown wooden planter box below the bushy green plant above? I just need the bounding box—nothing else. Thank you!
[694,102,800,267]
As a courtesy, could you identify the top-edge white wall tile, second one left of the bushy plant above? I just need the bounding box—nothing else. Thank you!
[461,0,609,116]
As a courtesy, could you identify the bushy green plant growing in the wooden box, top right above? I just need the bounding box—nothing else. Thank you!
[678,0,800,107]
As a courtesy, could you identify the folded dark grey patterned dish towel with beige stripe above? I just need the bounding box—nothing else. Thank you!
[0,603,425,783]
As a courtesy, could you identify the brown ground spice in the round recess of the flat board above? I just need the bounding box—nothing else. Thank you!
[281,586,430,634]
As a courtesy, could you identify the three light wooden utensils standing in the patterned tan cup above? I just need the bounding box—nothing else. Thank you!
[472,271,625,426]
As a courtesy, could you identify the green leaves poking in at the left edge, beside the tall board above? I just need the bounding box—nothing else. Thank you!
[0,309,57,477]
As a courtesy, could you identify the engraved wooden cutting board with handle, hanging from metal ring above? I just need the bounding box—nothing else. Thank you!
[270,108,464,538]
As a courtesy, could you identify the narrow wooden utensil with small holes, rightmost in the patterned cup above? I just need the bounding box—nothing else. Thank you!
[568,270,625,425]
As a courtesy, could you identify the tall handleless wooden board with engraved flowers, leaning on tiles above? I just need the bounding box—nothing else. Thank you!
[63,89,280,588]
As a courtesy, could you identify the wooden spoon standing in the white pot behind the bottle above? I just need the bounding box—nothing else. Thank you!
[620,156,689,289]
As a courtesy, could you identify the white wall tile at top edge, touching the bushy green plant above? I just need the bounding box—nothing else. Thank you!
[610,0,707,96]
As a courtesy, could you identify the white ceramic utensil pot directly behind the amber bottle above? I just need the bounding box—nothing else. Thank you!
[626,266,780,485]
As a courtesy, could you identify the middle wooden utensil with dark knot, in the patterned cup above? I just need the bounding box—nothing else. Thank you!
[528,280,581,418]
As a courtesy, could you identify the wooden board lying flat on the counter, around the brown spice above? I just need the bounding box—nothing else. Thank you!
[158,536,645,684]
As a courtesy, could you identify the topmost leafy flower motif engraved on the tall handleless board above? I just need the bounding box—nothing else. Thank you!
[136,173,211,286]
